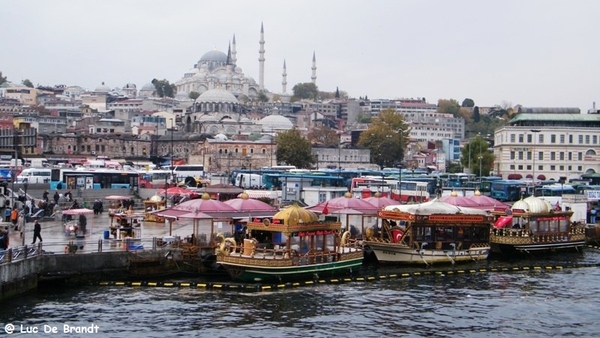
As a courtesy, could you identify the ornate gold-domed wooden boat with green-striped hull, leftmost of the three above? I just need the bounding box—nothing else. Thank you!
[216,204,363,283]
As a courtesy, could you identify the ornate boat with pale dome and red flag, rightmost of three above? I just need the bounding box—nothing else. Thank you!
[490,196,586,254]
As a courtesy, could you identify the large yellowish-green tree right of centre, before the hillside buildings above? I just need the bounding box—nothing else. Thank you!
[358,109,409,167]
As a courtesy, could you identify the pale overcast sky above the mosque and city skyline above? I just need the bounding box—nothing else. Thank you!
[0,0,600,111]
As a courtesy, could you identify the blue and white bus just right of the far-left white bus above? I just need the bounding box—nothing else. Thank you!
[50,168,140,190]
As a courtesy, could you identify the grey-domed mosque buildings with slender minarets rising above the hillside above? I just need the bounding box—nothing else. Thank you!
[171,23,317,135]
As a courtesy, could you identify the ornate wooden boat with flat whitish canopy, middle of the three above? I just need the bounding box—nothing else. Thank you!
[363,198,494,266]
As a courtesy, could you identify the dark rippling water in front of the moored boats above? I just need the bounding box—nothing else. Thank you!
[0,249,600,338]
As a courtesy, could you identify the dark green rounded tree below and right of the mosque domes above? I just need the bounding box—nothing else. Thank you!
[276,128,317,168]
